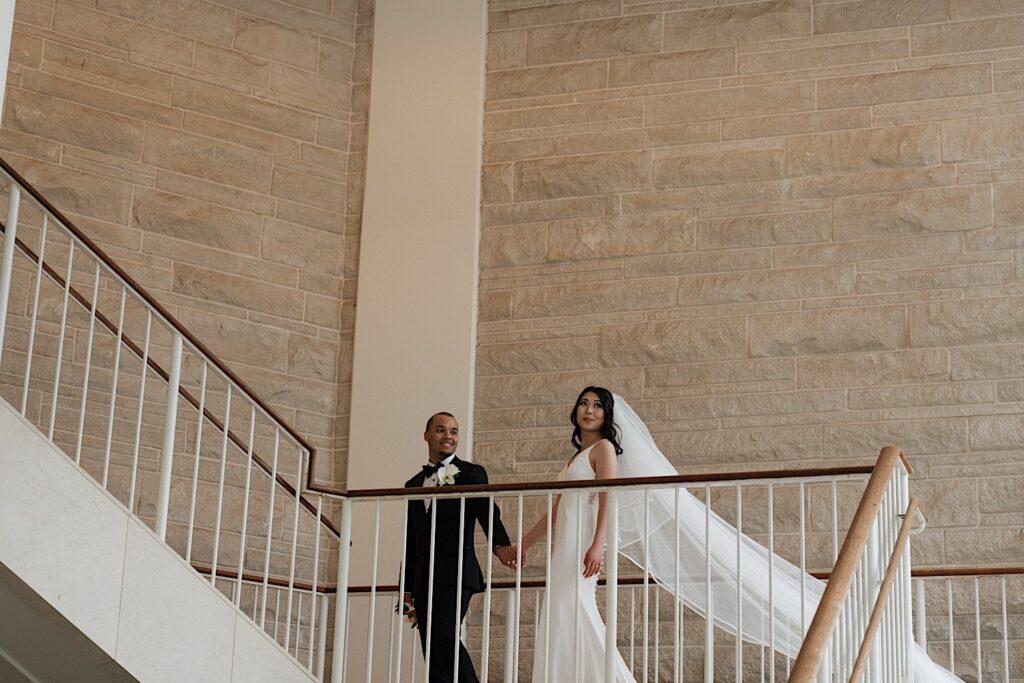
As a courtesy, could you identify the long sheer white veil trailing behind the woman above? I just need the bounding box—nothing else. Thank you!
[614,394,959,682]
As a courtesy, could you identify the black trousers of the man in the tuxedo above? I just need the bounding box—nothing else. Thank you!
[413,586,480,683]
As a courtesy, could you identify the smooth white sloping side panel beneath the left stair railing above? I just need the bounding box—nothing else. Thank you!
[0,400,313,683]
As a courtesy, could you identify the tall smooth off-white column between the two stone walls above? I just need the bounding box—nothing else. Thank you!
[347,0,486,680]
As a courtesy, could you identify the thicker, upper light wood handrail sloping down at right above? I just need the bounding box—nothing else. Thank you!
[790,445,902,683]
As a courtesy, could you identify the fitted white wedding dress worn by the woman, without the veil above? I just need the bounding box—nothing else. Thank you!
[531,445,635,683]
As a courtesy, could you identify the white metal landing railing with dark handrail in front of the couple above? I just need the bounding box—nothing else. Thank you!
[332,467,880,683]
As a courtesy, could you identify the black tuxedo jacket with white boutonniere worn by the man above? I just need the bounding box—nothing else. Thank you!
[403,457,510,595]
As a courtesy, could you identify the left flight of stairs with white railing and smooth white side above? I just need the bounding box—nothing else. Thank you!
[0,161,337,681]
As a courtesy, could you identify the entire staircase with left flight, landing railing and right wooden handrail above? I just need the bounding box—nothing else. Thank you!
[0,154,1024,683]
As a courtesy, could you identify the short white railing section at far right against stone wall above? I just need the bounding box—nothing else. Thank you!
[913,566,1024,683]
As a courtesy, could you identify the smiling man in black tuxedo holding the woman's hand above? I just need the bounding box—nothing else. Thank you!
[403,413,515,683]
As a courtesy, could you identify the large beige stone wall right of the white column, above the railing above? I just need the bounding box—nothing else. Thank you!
[475,0,1024,577]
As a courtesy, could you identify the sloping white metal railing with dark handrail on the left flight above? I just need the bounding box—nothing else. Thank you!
[0,160,338,669]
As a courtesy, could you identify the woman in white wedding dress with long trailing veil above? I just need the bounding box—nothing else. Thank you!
[517,386,959,683]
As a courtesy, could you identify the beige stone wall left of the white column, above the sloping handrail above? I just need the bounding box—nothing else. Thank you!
[0,0,372,489]
